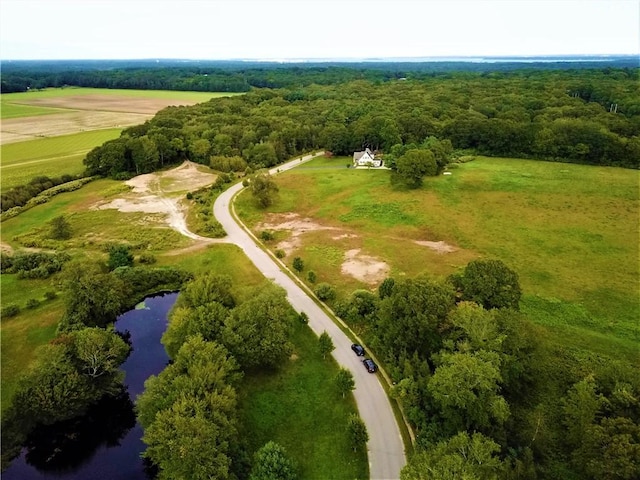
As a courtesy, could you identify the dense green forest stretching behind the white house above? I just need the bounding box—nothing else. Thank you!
[76,69,640,188]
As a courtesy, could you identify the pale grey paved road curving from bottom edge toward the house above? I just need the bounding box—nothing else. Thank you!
[213,154,406,480]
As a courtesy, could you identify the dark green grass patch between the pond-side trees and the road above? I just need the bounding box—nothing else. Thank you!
[239,323,369,480]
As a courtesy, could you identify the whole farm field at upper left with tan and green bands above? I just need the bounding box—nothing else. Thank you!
[0,87,233,191]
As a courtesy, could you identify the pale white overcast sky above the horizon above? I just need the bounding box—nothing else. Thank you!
[0,0,640,60]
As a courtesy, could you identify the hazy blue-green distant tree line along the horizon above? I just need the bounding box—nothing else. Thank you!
[0,56,638,93]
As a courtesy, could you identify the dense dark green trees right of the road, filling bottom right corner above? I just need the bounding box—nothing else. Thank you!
[330,260,640,480]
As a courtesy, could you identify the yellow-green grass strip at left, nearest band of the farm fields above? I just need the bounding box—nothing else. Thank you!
[0,128,122,191]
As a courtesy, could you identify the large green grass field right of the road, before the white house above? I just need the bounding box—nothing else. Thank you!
[237,157,640,358]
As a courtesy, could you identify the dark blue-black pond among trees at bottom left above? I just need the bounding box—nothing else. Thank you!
[2,293,178,480]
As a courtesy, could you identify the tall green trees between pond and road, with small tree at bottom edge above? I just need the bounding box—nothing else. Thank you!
[137,274,296,479]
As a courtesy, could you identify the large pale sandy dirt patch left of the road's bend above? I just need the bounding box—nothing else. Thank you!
[93,162,222,243]
